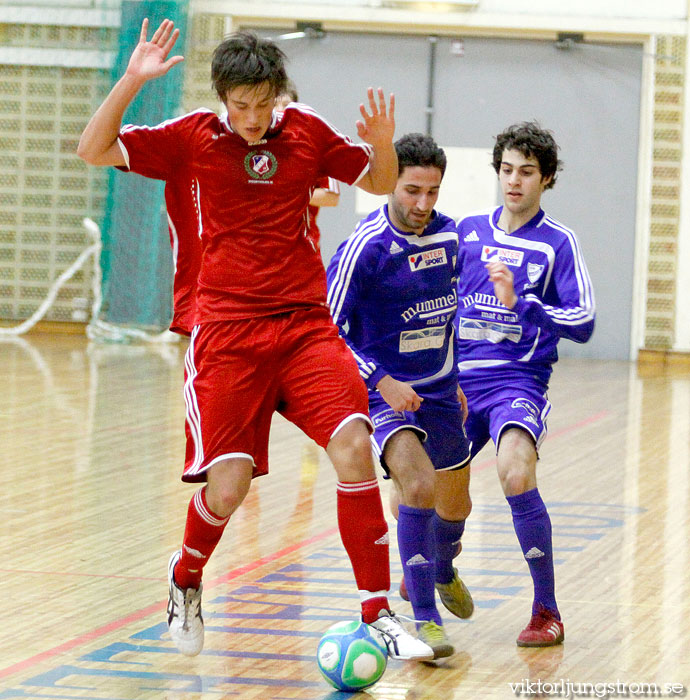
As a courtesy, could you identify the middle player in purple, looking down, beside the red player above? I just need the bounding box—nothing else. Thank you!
[327,134,474,658]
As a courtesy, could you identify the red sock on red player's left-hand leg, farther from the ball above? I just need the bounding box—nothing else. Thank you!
[175,486,230,588]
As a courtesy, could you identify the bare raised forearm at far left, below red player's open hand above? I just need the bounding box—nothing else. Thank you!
[77,73,145,165]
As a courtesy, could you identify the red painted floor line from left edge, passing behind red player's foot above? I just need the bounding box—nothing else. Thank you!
[0,527,338,678]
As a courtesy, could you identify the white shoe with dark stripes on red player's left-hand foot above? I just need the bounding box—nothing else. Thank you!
[168,550,204,656]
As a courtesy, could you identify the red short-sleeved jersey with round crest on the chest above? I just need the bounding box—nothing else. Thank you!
[120,104,371,323]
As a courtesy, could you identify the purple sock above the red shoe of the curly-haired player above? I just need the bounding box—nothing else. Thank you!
[506,489,561,620]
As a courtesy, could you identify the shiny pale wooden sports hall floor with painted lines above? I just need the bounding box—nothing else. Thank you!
[0,334,690,700]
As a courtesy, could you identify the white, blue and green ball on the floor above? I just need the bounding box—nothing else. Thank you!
[316,622,388,693]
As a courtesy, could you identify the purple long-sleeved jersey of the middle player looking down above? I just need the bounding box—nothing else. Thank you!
[326,205,458,397]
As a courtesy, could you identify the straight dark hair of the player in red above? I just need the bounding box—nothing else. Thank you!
[211,31,288,102]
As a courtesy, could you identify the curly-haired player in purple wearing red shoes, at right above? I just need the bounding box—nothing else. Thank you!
[456,122,594,647]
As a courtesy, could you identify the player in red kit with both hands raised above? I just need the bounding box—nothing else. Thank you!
[78,20,433,659]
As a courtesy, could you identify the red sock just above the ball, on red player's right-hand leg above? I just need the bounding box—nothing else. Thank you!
[338,479,391,622]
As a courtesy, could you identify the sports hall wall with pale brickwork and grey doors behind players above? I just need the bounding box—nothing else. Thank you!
[0,6,687,359]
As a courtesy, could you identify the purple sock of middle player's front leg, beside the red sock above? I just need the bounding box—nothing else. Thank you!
[398,505,441,624]
